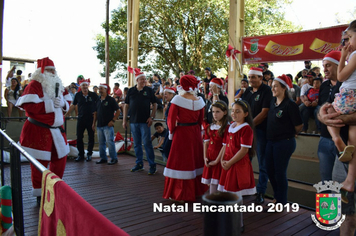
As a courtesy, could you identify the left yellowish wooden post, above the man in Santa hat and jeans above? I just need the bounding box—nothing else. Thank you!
[127,0,140,87]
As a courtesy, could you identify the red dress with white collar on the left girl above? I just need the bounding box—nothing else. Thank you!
[201,124,229,185]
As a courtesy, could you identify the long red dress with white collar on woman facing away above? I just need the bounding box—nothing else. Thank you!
[163,96,208,201]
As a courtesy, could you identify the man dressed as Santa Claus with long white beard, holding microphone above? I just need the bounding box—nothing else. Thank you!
[16,57,72,203]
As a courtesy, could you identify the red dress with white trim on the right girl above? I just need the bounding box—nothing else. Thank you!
[218,123,256,196]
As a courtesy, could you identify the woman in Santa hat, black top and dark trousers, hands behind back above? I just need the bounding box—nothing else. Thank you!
[266,75,303,204]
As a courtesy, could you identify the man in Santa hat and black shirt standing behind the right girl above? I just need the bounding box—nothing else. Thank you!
[242,67,272,204]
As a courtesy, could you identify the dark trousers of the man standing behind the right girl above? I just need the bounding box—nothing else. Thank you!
[256,129,268,194]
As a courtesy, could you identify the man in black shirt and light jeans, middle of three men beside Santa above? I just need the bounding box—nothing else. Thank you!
[93,84,120,165]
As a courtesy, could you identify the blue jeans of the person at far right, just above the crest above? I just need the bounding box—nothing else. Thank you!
[318,136,338,181]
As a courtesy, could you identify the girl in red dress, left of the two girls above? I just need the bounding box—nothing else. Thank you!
[201,101,229,193]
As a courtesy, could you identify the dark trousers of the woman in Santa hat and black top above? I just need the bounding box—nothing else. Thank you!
[266,138,296,204]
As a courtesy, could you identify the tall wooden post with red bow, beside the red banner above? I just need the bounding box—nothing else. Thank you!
[228,0,245,103]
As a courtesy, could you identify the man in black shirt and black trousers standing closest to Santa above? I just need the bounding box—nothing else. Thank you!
[66,80,98,162]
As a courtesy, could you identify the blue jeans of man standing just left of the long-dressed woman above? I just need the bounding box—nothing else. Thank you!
[130,123,156,166]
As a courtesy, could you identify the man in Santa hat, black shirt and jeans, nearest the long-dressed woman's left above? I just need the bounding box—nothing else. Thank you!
[122,67,157,175]
